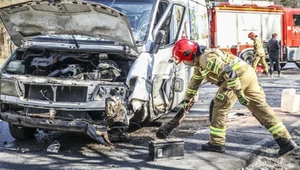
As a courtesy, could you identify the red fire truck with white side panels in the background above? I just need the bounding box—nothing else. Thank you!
[208,2,300,68]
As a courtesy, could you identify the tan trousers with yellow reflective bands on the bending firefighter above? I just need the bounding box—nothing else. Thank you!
[209,65,291,146]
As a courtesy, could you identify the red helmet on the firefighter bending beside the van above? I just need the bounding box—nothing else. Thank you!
[172,39,198,63]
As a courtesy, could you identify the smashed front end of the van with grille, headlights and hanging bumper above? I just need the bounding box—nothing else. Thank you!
[0,76,129,146]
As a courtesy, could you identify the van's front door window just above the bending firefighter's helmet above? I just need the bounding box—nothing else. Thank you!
[160,5,184,46]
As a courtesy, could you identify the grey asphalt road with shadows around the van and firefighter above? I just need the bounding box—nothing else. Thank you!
[0,64,300,170]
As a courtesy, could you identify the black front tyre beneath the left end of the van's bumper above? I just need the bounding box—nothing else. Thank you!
[8,123,36,140]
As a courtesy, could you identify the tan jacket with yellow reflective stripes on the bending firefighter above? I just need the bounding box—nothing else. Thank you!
[186,49,246,99]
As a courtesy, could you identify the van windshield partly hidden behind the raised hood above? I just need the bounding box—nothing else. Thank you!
[86,0,156,44]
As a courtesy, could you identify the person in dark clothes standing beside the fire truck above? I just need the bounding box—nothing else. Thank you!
[267,33,280,77]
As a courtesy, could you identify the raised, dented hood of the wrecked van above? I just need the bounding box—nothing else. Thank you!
[0,0,137,51]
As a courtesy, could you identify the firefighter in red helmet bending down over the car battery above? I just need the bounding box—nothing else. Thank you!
[156,39,296,155]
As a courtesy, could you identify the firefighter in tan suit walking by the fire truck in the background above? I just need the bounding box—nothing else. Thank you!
[248,32,268,75]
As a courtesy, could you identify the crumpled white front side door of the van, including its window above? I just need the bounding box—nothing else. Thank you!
[150,4,188,114]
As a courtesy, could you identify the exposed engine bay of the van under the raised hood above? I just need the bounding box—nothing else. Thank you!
[4,49,133,82]
